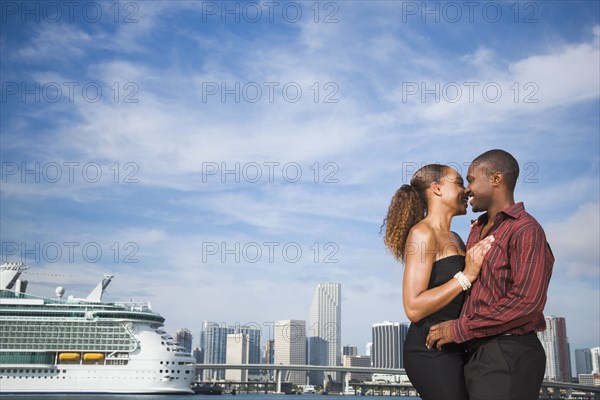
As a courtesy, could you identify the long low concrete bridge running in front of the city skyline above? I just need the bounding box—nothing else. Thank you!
[196,364,600,400]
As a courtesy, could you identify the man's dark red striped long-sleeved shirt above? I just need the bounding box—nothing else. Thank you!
[453,203,554,343]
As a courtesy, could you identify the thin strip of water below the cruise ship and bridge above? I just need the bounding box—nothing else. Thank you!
[2,393,419,400]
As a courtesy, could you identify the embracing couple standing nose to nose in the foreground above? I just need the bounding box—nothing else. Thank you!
[384,150,554,400]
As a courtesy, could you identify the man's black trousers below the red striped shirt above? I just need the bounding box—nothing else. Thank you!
[465,332,546,400]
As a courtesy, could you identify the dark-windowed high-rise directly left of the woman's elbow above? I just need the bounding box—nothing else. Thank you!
[371,321,408,368]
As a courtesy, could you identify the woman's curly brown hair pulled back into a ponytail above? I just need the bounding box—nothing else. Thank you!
[380,164,448,262]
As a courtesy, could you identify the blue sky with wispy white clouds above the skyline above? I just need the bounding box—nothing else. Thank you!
[0,1,600,368]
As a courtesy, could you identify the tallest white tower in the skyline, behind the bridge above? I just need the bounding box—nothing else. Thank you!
[308,283,342,385]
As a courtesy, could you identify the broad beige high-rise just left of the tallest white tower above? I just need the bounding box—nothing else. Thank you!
[273,319,306,385]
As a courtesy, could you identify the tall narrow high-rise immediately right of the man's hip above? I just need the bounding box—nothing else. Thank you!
[538,315,572,382]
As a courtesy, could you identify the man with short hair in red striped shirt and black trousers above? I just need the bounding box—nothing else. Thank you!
[426,150,554,400]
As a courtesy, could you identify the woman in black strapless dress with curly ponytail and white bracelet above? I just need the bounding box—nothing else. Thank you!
[383,164,494,400]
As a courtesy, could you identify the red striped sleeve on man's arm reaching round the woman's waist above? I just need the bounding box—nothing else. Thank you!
[453,224,554,343]
